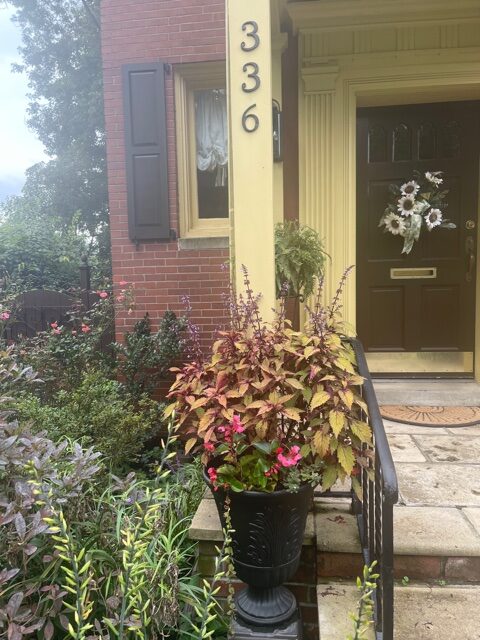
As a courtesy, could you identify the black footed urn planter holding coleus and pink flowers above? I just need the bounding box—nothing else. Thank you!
[206,470,313,637]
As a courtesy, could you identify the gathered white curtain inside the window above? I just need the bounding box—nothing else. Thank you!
[195,89,228,187]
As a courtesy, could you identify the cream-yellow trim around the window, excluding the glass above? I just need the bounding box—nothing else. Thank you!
[174,62,230,238]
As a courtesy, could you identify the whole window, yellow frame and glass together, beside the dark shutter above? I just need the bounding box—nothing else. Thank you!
[175,62,230,238]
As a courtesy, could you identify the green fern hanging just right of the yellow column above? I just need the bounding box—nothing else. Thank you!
[275,221,327,299]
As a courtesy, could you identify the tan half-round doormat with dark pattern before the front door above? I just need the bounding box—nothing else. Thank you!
[380,405,480,427]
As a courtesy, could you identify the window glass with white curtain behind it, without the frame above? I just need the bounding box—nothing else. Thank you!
[195,89,228,219]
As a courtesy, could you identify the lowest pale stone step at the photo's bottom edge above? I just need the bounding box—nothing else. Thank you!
[317,581,480,640]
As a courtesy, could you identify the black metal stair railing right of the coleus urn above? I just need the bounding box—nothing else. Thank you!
[315,340,398,640]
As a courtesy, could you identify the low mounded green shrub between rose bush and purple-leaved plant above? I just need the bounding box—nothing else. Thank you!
[9,371,162,468]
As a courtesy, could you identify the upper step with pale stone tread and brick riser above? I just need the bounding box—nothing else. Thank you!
[314,499,480,584]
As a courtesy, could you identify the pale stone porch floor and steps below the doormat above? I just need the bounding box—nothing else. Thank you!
[315,418,480,640]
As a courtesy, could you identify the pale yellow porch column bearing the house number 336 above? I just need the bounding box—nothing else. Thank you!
[226,0,275,320]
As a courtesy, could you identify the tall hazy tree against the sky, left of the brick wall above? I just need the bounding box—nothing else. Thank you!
[2,0,110,286]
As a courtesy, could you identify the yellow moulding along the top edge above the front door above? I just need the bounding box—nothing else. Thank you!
[287,0,480,30]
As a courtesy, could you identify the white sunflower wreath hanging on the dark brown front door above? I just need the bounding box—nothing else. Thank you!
[378,171,456,254]
